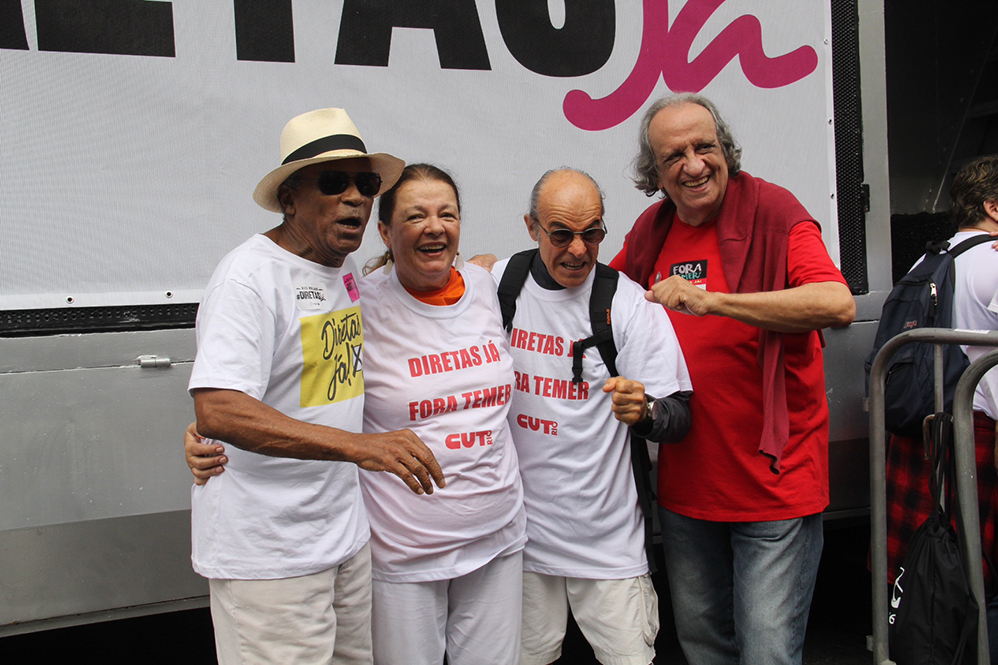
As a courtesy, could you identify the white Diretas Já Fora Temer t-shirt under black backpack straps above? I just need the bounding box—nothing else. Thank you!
[492,260,692,579]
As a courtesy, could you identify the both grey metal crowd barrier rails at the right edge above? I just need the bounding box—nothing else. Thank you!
[869,328,998,665]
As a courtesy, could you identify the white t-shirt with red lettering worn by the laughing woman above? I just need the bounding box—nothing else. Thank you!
[362,265,526,583]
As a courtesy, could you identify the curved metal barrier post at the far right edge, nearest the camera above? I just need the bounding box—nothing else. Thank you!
[953,350,998,665]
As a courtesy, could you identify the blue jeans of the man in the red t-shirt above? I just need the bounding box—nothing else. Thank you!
[658,506,824,665]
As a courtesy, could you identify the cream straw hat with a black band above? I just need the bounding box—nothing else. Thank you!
[253,109,405,212]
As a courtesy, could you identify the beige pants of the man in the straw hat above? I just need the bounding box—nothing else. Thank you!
[208,545,373,665]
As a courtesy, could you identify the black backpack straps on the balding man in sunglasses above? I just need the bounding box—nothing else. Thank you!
[499,249,656,573]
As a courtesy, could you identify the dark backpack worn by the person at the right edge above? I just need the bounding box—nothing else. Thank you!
[866,233,995,439]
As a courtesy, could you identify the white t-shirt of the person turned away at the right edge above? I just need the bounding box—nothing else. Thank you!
[949,231,998,419]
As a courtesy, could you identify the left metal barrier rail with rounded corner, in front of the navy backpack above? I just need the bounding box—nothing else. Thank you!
[869,328,998,665]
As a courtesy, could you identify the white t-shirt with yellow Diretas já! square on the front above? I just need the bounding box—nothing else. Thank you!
[189,235,369,579]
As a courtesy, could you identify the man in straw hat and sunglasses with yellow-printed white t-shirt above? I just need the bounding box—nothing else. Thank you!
[189,109,443,665]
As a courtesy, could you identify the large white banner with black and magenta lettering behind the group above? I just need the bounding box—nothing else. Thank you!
[0,0,838,310]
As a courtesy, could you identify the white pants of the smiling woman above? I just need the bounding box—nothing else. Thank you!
[371,551,523,665]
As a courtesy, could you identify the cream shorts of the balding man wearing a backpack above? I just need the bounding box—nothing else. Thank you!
[520,573,658,665]
